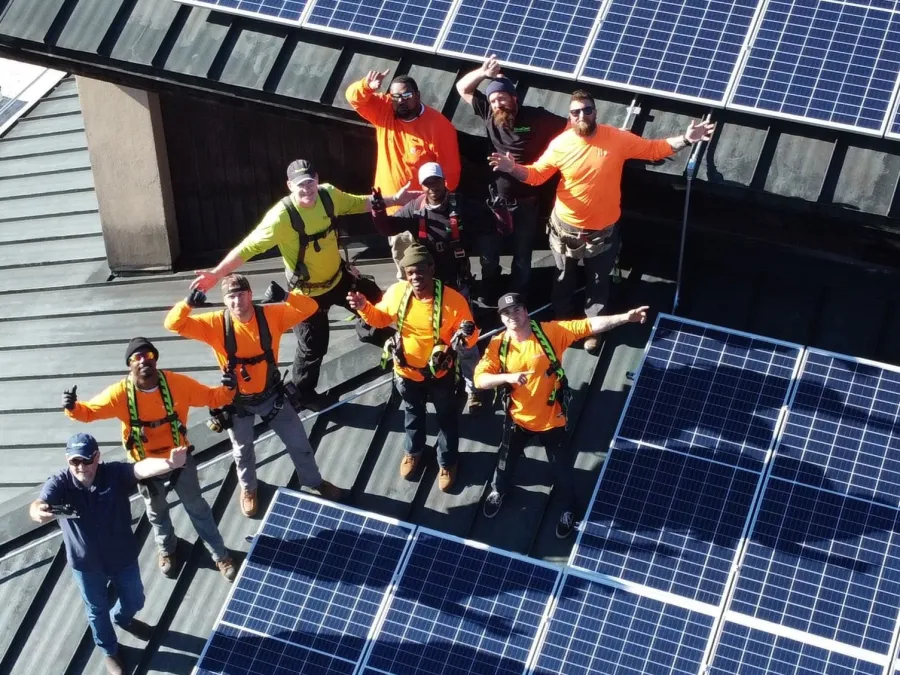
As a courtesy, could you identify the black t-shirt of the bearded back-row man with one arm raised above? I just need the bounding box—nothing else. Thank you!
[472,89,566,197]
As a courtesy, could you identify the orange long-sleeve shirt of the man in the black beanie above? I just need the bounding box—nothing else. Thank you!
[65,370,234,462]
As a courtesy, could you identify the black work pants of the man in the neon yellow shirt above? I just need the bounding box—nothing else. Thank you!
[293,271,382,397]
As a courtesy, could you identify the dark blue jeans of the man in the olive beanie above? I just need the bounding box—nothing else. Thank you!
[394,373,460,468]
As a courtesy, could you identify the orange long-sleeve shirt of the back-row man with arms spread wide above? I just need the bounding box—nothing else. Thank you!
[524,124,675,230]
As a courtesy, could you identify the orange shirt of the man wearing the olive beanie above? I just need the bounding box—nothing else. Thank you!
[359,281,478,382]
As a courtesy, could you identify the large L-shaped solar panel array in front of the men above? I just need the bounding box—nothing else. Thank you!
[198,315,900,675]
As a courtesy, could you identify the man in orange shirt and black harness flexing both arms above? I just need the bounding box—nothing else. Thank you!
[165,274,341,518]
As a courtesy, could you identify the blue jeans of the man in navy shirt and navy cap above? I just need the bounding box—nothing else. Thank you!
[72,560,144,656]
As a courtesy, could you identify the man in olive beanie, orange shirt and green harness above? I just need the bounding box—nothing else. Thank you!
[347,244,478,492]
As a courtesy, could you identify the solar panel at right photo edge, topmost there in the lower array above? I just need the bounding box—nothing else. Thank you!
[774,350,900,504]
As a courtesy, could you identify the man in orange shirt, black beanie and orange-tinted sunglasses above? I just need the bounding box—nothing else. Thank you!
[62,337,237,581]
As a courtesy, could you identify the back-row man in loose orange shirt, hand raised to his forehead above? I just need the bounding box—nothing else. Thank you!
[346,70,461,279]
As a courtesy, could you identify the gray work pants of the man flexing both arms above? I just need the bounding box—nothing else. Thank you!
[228,394,322,492]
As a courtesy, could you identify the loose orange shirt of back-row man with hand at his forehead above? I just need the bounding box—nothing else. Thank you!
[347,79,461,213]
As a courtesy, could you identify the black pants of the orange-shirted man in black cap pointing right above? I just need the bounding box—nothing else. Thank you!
[491,417,575,511]
